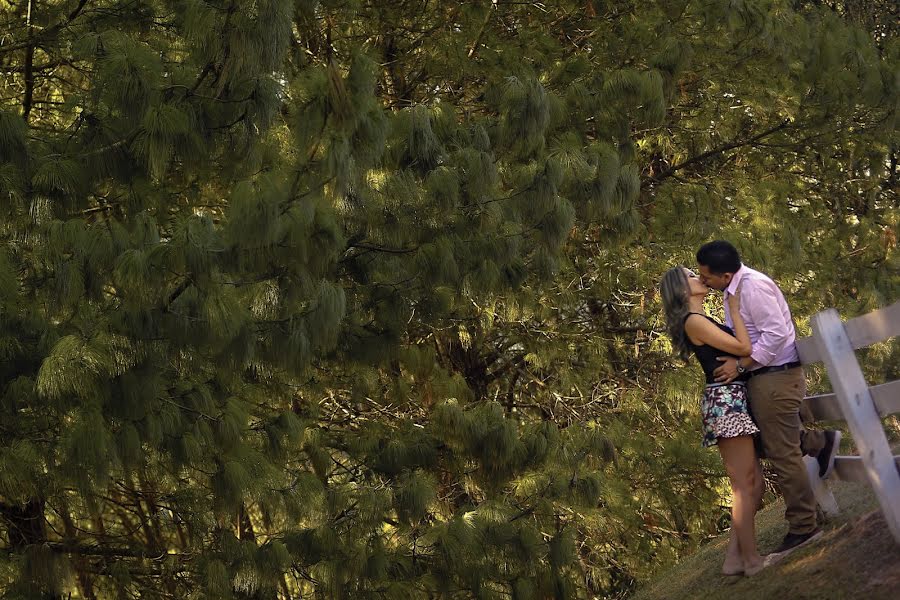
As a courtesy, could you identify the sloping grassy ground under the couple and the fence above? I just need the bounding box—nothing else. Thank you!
[631,482,900,600]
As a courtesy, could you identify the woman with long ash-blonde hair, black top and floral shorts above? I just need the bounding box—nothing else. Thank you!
[660,266,776,575]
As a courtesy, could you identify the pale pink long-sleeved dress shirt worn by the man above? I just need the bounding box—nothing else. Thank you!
[725,265,800,368]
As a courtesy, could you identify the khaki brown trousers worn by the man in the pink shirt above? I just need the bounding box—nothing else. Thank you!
[749,368,825,533]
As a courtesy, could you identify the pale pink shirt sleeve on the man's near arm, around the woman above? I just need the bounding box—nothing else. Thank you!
[741,280,793,366]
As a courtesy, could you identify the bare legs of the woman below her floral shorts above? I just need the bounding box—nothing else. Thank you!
[718,435,762,571]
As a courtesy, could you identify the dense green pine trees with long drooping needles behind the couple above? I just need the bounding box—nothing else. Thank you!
[0,0,900,599]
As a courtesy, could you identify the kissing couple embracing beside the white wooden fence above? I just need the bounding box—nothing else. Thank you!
[660,240,841,576]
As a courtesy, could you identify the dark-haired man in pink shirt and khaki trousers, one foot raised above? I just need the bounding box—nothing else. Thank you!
[697,240,840,553]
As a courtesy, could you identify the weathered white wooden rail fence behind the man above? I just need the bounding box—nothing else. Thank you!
[797,302,900,544]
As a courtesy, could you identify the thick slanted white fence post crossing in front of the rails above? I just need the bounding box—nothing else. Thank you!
[812,308,900,543]
